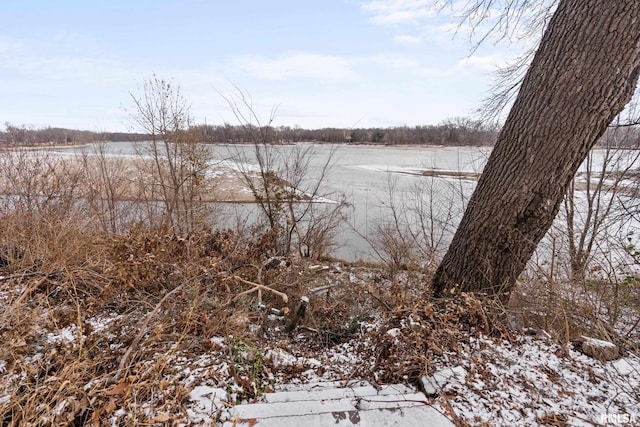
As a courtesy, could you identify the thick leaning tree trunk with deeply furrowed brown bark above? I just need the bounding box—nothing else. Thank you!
[433,0,640,300]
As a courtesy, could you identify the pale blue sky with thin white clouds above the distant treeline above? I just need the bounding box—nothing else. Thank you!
[0,0,515,131]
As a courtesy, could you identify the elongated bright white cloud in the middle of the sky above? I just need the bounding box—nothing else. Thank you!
[233,52,357,80]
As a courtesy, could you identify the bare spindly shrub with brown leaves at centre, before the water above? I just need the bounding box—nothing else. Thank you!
[225,88,347,258]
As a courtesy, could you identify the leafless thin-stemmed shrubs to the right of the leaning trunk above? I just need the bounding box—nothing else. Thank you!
[512,118,640,348]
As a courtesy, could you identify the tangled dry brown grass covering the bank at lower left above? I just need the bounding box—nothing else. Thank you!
[0,221,278,426]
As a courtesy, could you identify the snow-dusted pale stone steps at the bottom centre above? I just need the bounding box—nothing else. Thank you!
[225,382,454,427]
